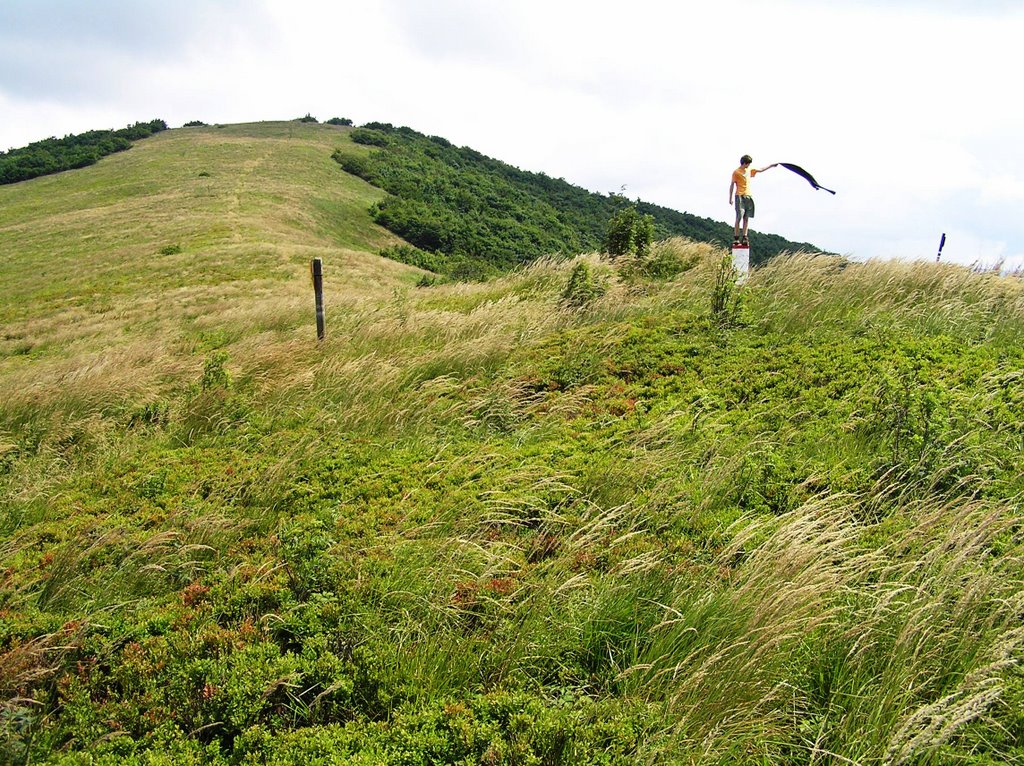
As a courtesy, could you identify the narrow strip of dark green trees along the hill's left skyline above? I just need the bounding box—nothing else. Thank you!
[0,120,167,183]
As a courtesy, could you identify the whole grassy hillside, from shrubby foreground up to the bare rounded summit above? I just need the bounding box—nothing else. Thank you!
[0,123,1024,765]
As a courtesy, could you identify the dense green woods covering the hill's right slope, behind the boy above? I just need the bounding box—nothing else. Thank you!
[335,123,814,275]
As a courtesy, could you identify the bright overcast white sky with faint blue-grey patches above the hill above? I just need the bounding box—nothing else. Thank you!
[0,0,1024,267]
